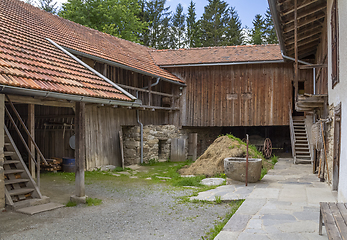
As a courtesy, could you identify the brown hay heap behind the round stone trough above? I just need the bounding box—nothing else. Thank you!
[178,136,264,177]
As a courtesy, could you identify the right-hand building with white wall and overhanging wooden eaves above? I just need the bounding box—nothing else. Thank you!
[268,0,347,202]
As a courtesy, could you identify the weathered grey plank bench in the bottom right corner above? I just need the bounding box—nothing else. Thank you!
[319,202,347,240]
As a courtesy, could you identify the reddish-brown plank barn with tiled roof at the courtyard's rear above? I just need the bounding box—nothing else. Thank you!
[151,45,312,156]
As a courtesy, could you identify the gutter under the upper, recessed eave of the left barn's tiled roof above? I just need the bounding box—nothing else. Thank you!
[64,47,186,86]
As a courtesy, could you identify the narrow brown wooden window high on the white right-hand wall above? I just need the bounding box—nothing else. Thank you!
[331,0,340,88]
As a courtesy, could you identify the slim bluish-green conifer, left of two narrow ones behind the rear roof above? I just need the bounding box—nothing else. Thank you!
[170,3,186,49]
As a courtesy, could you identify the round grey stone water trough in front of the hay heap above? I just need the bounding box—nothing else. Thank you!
[224,157,262,183]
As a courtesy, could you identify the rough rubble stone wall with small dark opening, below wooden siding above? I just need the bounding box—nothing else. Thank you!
[123,125,187,165]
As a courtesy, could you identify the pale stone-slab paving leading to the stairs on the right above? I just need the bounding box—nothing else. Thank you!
[195,158,336,240]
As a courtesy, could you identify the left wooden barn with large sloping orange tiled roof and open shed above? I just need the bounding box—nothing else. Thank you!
[0,0,185,208]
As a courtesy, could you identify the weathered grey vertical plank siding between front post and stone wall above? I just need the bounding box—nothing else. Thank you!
[86,105,169,169]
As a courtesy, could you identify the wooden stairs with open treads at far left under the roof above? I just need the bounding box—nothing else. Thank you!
[4,125,42,208]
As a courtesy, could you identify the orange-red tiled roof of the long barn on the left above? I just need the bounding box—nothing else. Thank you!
[0,0,181,101]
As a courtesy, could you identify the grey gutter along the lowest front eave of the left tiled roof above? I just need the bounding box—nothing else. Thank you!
[0,85,142,107]
